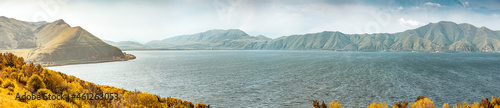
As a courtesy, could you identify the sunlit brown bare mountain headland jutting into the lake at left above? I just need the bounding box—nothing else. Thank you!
[0,16,131,65]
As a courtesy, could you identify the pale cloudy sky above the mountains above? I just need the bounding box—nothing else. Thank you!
[0,0,500,43]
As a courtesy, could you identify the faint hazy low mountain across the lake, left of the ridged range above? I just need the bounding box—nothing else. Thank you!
[145,29,271,49]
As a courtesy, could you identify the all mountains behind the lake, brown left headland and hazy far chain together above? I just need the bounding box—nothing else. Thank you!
[0,16,500,65]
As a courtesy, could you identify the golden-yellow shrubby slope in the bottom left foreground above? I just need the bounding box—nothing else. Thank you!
[0,53,210,108]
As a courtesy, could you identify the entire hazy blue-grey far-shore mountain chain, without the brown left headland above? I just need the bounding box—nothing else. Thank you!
[146,21,500,52]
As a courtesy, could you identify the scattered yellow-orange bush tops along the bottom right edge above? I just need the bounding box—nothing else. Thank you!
[313,96,500,108]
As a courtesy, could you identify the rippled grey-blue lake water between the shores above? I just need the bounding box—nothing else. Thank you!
[49,50,500,108]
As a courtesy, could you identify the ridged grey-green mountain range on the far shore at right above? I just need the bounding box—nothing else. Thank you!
[264,21,500,52]
